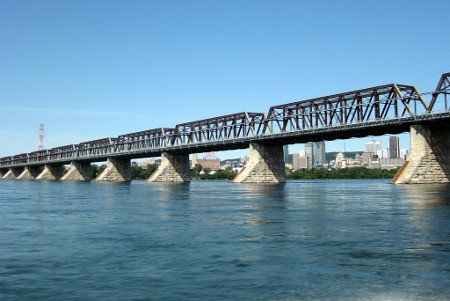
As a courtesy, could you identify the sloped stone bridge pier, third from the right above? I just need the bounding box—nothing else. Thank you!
[148,153,191,183]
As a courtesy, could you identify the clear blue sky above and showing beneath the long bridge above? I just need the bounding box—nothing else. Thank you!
[0,0,450,158]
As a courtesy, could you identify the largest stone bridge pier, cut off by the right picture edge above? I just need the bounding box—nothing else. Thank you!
[392,125,450,184]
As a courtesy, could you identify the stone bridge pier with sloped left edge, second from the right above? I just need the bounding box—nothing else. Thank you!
[232,142,286,183]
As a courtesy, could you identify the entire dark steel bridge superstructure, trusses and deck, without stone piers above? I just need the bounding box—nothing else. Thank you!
[0,73,450,169]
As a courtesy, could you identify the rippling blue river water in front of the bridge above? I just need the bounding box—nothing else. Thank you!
[0,180,450,300]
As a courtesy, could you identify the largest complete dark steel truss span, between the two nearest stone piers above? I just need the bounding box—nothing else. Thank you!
[267,84,427,133]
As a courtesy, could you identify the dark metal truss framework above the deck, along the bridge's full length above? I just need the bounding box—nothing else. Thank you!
[0,73,450,168]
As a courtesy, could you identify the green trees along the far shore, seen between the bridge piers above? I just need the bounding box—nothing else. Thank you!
[93,164,398,180]
